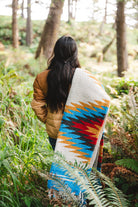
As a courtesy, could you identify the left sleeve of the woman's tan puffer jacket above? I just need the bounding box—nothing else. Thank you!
[31,75,47,123]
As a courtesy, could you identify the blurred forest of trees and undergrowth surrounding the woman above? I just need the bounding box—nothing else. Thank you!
[0,0,138,207]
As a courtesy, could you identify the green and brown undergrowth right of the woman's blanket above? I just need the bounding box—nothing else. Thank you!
[103,76,138,206]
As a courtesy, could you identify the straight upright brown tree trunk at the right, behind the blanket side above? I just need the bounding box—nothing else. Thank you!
[116,1,128,77]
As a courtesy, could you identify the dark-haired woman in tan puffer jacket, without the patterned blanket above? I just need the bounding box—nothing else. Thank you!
[31,36,80,150]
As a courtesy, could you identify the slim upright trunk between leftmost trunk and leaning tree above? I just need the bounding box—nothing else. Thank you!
[26,0,32,46]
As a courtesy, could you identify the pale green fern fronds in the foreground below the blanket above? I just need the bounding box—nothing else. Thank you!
[48,154,128,207]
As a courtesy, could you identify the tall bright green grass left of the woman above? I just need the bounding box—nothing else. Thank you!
[0,59,51,207]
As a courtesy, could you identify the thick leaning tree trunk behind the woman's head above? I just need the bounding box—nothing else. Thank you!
[35,0,64,59]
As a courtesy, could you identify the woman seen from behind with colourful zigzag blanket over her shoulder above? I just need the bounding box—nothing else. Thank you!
[32,36,110,203]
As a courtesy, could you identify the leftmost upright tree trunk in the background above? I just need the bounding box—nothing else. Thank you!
[12,0,19,48]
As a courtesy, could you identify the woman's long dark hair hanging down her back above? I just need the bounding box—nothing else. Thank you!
[47,36,80,112]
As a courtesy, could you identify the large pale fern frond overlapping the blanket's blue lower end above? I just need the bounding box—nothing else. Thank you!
[54,155,109,207]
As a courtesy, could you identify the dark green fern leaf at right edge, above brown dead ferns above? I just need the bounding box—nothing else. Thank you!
[115,159,138,173]
